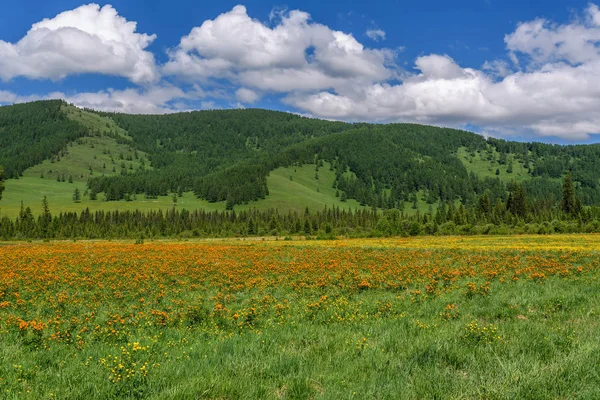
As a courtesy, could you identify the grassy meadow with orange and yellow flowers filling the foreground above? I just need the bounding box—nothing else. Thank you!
[0,235,600,399]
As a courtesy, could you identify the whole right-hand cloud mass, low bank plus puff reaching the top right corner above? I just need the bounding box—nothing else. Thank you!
[285,5,600,140]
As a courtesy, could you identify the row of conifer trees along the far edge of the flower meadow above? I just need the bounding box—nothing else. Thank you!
[0,174,600,240]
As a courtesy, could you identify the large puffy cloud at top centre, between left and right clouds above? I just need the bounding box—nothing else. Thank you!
[163,5,394,91]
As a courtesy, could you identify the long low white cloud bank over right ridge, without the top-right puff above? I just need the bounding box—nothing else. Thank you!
[286,52,600,140]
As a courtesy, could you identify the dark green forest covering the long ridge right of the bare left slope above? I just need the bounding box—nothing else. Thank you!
[85,110,600,209]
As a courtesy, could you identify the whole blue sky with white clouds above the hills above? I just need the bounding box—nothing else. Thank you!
[0,0,600,143]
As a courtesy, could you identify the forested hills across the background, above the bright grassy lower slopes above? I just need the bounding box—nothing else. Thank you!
[0,101,600,212]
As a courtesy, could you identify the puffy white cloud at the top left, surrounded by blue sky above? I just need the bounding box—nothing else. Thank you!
[0,4,159,83]
